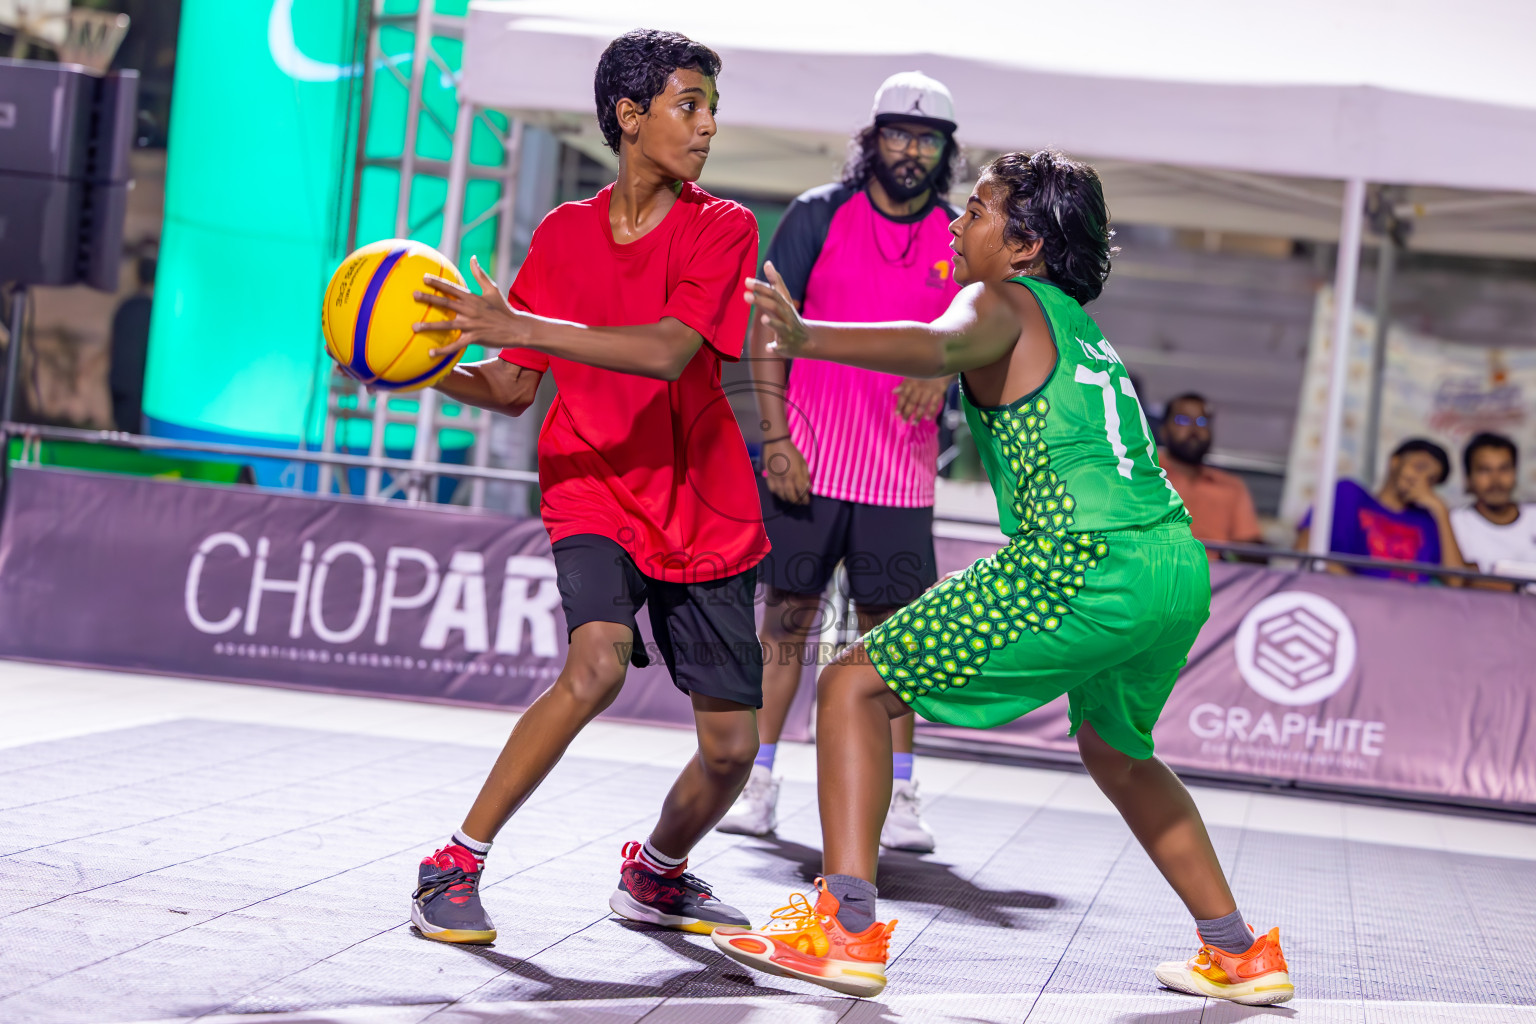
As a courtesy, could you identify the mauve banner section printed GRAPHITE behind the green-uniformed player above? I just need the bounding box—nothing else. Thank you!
[919,542,1536,808]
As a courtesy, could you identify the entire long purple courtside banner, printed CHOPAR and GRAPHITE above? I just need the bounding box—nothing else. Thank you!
[0,468,1536,806]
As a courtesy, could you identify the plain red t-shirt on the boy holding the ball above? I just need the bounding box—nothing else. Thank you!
[501,184,768,583]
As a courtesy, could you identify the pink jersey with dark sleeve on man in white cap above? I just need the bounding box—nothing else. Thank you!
[768,186,960,508]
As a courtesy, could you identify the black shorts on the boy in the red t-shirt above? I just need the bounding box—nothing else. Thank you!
[551,533,763,708]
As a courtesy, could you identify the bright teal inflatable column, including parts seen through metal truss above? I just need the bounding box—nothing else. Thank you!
[144,0,507,469]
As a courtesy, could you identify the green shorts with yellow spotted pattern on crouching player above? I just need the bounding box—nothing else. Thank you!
[863,524,1210,757]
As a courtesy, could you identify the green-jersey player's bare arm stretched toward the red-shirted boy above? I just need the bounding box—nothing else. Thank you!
[745,263,1021,378]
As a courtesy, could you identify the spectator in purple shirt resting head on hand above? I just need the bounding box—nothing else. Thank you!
[1296,438,1468,583]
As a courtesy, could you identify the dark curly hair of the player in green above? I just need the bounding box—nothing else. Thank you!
[982,149,1120,306]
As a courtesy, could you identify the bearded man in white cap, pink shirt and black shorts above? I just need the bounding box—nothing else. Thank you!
[719,71,960,854]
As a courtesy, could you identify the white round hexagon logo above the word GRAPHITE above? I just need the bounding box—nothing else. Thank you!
[1235,591,1355,706]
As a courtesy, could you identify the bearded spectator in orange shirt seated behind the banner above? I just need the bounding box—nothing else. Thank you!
[1158,391,1263,543]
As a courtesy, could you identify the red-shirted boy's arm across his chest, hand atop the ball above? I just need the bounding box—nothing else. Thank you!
[415,258,703,381]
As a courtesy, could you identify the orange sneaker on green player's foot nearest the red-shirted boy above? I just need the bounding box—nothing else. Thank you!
[713,878,895,998]
